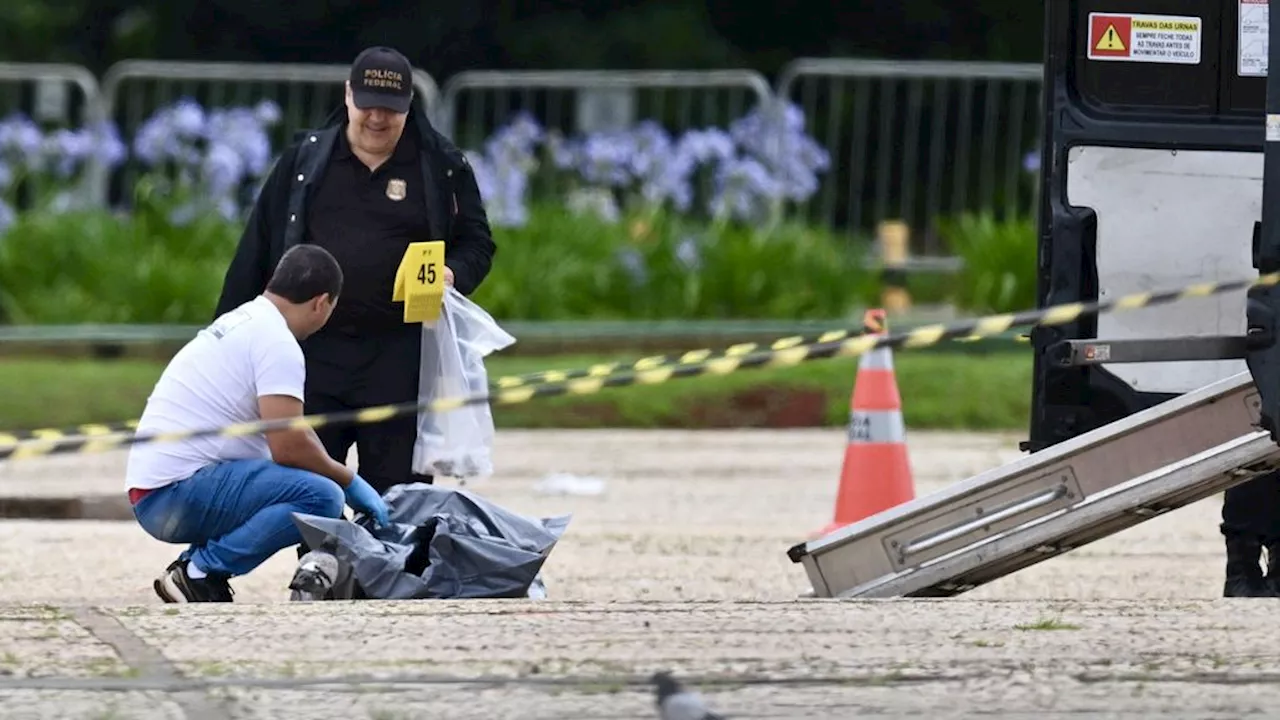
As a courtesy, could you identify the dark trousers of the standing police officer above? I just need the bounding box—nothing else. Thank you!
[302,324,433,493]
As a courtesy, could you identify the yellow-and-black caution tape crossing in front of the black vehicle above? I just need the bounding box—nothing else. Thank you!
[0,267,1280,460]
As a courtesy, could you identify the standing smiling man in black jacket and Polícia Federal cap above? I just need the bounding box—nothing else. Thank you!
[216,47,497,493]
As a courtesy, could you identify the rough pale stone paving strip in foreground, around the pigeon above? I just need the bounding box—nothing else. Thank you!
[0,598,1280,719]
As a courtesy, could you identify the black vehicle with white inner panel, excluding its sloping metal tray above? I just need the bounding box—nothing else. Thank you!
[1023,0,1280,452]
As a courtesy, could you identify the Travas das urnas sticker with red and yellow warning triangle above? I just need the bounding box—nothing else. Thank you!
[1088,13,1203,65]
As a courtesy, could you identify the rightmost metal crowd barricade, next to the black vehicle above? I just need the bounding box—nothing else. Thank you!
[777,59,1043,255]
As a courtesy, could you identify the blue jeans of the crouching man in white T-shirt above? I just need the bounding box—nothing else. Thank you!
[133,460,346,577]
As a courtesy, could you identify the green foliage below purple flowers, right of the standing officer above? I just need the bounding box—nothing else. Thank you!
[475,198,878,320]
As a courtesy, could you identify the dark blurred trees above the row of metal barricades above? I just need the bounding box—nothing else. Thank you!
[0,0,1043,82]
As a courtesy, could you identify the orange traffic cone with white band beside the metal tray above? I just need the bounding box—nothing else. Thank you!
[820,304,915,534]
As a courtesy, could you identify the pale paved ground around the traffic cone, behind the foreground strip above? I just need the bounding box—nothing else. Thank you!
[0,430,1222,603]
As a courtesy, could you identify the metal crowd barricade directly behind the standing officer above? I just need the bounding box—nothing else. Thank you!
[92,60,440,204]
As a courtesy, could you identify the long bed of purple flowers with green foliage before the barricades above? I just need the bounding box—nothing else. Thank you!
[0,99,1036,324]
